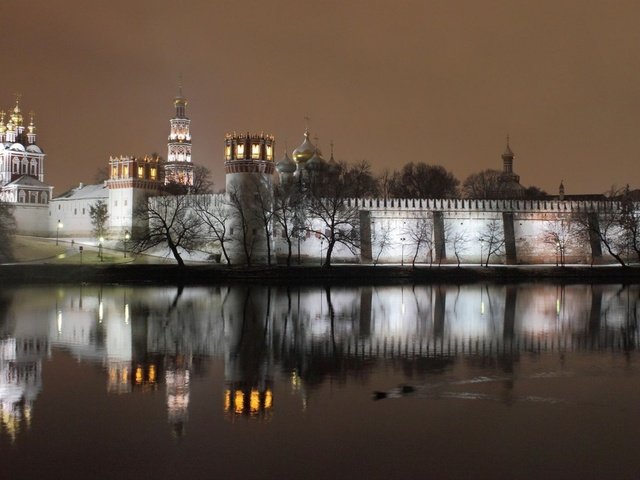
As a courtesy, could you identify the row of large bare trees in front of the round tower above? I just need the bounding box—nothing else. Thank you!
[133,160,364,266]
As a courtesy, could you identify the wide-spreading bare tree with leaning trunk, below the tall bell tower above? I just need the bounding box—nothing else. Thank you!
[132,194,202,267]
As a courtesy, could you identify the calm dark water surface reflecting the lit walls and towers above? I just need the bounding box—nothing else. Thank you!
[0,284,640,479]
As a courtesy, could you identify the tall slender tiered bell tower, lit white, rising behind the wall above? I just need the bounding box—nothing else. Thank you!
[164,80,193,187]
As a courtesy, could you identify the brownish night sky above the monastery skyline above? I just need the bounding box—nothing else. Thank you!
[5,0,640,195]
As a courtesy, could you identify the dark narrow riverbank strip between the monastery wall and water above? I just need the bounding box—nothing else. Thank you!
[0,264,640,286]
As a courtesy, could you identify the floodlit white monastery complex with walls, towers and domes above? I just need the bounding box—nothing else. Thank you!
[0,93,636,265]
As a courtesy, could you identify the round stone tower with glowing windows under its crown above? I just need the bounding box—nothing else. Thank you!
[224,133,275,265]
